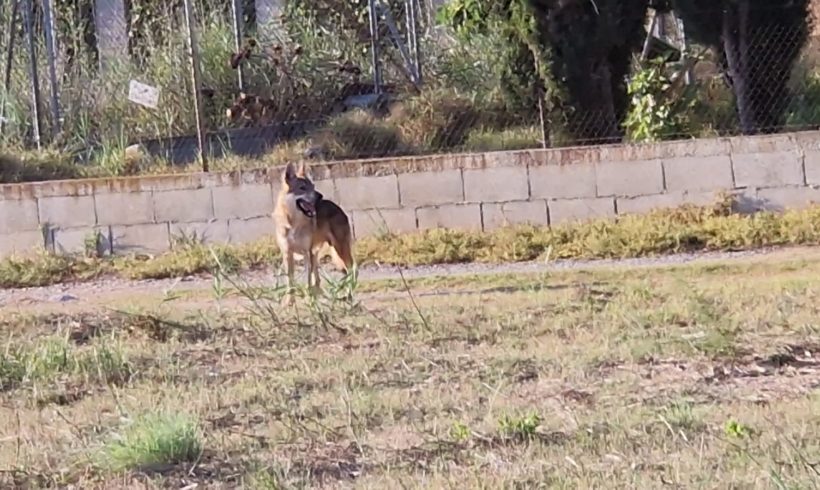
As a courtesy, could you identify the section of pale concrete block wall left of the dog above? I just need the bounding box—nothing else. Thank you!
[0,170,279,255]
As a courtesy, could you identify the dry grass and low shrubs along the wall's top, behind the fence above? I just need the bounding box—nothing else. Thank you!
[0,89,541,183]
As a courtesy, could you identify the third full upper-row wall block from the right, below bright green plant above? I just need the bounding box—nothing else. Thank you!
[595,160,663,197]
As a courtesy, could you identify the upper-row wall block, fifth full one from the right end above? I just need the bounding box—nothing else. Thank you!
[464,165,530,202]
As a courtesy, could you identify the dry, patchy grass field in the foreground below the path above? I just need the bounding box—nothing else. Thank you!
[0,247,820,489]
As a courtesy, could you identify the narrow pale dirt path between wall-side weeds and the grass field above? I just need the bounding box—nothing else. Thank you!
[0,247,820,312]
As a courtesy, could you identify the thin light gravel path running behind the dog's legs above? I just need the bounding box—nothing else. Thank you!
[0,249,796,307]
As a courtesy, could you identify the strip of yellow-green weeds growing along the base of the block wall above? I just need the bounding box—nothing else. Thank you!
[8,200,820,288]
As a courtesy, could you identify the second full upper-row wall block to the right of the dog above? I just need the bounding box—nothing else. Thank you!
[399,170,464,207]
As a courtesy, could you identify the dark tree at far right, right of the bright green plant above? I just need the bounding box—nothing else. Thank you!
[673,0,810,134]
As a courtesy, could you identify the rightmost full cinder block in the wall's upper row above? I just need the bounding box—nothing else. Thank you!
[732,151,805,187]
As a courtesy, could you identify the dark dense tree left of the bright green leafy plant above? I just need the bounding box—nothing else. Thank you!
[438,0,649,143]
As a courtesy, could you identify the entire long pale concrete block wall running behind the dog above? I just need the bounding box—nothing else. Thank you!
[0,132,820,255]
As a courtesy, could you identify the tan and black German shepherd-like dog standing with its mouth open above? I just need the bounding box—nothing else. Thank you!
[273,163,354,304]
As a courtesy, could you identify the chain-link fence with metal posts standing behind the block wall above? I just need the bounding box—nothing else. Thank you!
[0,0,820,173]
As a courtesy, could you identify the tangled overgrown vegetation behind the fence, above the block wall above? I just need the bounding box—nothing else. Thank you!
[0,0,820,182]
